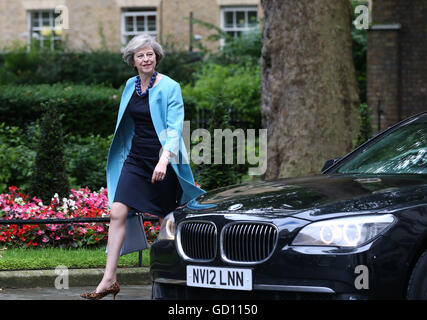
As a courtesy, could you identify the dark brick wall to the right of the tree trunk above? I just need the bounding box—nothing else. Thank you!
[367,0,427,130]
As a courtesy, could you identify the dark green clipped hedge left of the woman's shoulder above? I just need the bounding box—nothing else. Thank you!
[0,84,122,137]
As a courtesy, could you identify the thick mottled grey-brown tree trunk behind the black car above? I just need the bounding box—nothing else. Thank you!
[261,0,359,180]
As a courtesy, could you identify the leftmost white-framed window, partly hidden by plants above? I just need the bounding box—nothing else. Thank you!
[28,10,61,50]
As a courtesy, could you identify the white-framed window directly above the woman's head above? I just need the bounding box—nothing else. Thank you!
[122,9,157,45]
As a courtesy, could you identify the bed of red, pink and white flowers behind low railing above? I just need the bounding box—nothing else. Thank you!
[0,186,160,248]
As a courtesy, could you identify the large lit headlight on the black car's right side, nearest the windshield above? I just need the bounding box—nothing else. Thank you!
[292,214,395,247]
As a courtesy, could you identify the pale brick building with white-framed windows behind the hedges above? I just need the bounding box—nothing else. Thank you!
[0,0,261,51]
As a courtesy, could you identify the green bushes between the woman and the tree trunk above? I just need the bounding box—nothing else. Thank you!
[177,19,261,190]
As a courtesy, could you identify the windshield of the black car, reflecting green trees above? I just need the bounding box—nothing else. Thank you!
[334,116,427,174]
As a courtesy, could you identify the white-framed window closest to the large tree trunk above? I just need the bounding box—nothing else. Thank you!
[221,6,258,37]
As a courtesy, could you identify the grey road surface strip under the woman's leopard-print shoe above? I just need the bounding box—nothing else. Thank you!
[0,285,151,300]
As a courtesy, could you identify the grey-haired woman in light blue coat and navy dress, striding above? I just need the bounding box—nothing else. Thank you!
[81,34,204,299]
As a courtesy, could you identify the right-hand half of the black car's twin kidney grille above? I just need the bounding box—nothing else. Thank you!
[221,223,278,263]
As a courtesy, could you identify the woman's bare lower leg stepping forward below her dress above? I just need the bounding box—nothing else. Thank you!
[96,202,129,292]
